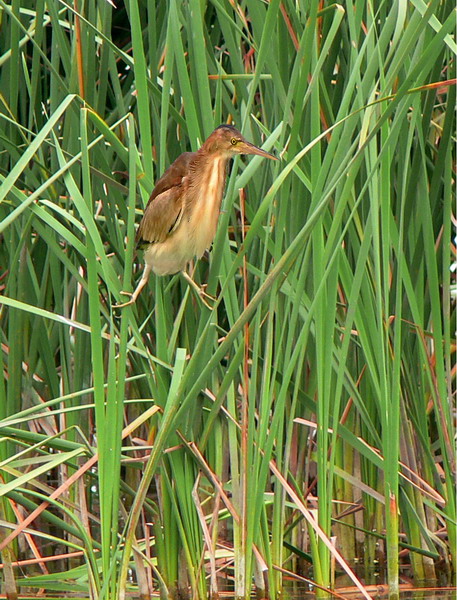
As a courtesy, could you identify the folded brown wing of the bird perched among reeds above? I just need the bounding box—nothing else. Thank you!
[136,152,195,246]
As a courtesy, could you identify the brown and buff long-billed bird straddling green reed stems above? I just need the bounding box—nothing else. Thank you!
[115,124,278,308]
